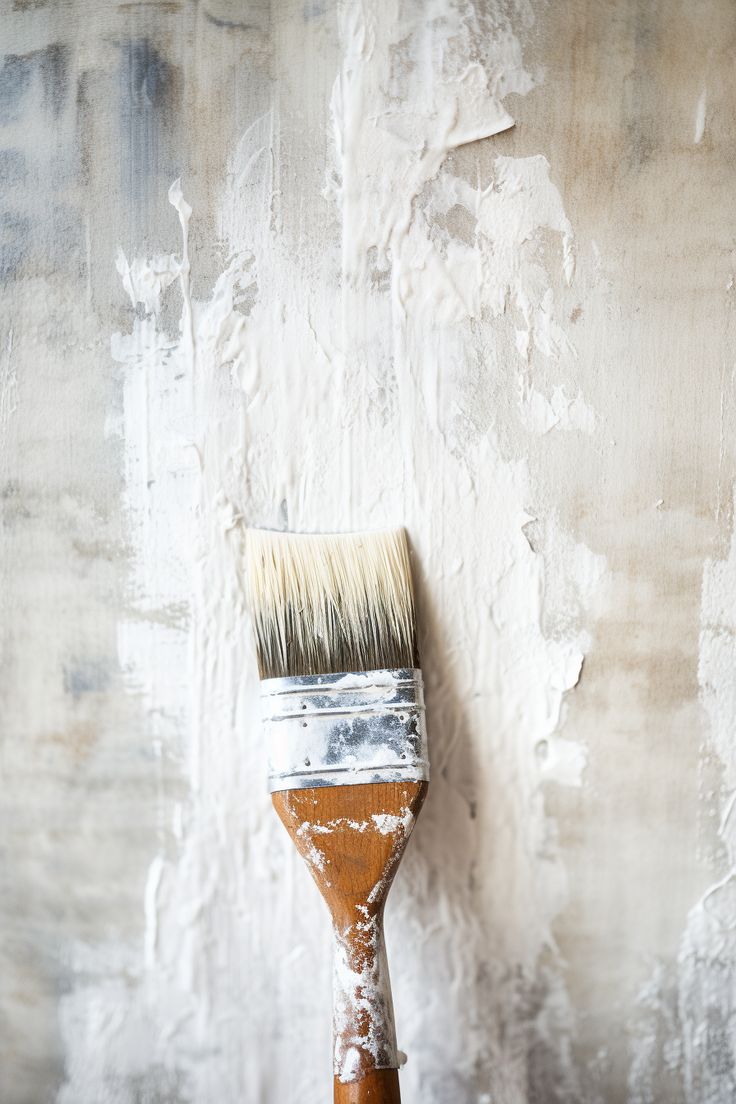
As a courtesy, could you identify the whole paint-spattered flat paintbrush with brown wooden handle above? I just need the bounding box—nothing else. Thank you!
[246,530,429,1104]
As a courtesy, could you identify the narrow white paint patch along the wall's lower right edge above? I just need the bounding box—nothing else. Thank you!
[628,501,736,1104]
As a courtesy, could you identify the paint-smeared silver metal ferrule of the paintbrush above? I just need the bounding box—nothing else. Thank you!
[260,668,429,793]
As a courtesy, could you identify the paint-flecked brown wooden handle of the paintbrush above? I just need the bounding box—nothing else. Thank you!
[273,782,427,1090]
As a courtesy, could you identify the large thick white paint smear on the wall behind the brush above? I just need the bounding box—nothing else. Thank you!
[57,0,605,1104]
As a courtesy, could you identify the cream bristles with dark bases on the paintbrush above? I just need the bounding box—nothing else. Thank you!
[246,529,419,679]
